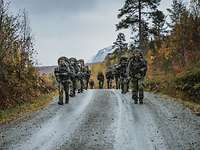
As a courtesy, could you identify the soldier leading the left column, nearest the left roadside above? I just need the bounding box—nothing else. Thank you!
[54,57,70,105]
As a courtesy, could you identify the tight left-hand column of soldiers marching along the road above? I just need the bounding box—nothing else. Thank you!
[54,57,91,105]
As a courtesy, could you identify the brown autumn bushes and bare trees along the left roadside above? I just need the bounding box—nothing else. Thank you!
[0,0,55,122]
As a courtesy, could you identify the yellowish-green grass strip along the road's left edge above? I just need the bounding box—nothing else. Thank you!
[0,92,57,124]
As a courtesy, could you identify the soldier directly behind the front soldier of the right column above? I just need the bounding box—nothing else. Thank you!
[119,57,129,94]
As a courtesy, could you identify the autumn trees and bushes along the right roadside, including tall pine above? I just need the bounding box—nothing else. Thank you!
[101,0,200,112]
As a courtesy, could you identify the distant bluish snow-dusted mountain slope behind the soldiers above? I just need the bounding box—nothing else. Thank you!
[89,46,114,63]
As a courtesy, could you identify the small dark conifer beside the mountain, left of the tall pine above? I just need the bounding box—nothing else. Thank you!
[113,33,128,51]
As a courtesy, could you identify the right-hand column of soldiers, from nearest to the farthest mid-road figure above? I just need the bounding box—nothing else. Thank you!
[97,50,147,104]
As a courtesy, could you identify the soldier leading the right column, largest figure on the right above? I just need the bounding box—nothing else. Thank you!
[127,50,147,104]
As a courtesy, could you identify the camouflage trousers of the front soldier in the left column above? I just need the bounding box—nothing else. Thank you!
[58,81,69,105]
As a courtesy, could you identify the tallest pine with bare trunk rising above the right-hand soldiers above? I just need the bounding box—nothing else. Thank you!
[116,0,160,48]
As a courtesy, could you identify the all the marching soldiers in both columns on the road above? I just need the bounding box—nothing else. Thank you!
[54,50,147,105]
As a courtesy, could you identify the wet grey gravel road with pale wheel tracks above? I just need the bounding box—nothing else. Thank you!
[0,90,200,150]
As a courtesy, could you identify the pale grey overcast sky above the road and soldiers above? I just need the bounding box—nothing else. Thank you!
[10,0,174,66]
